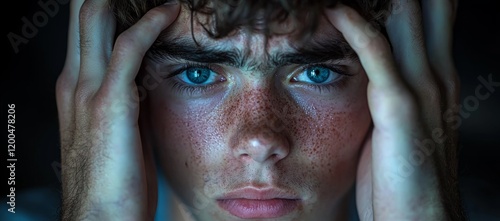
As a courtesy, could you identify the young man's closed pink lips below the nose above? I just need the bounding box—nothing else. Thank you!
[217,187,300,219]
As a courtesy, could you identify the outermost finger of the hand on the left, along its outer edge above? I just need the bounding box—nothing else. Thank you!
[56,0,84,147]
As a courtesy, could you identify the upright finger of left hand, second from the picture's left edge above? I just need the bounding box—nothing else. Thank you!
[79,0,115,87]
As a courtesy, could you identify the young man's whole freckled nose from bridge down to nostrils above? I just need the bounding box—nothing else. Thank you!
[230,88,290,163]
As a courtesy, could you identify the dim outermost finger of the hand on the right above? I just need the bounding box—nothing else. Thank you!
[422,0,460,108]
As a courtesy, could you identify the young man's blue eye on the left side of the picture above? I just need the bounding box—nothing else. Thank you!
[178,67,218,86]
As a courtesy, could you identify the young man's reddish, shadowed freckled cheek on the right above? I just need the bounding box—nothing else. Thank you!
[292,91,371,199]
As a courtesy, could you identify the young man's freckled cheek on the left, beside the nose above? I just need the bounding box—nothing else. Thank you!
[151,97,224,201]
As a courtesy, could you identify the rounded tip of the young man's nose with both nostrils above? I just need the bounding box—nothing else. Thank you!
[234,127,290,163]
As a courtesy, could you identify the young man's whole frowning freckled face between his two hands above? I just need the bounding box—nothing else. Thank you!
[141,4,371,220]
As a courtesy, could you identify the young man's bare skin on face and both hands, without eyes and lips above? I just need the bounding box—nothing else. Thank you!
[56,0,463,220]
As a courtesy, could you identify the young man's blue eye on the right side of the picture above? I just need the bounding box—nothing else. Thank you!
[293,65,340,84]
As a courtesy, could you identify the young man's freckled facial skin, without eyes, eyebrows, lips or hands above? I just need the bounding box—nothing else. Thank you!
[139,4,371,220]
